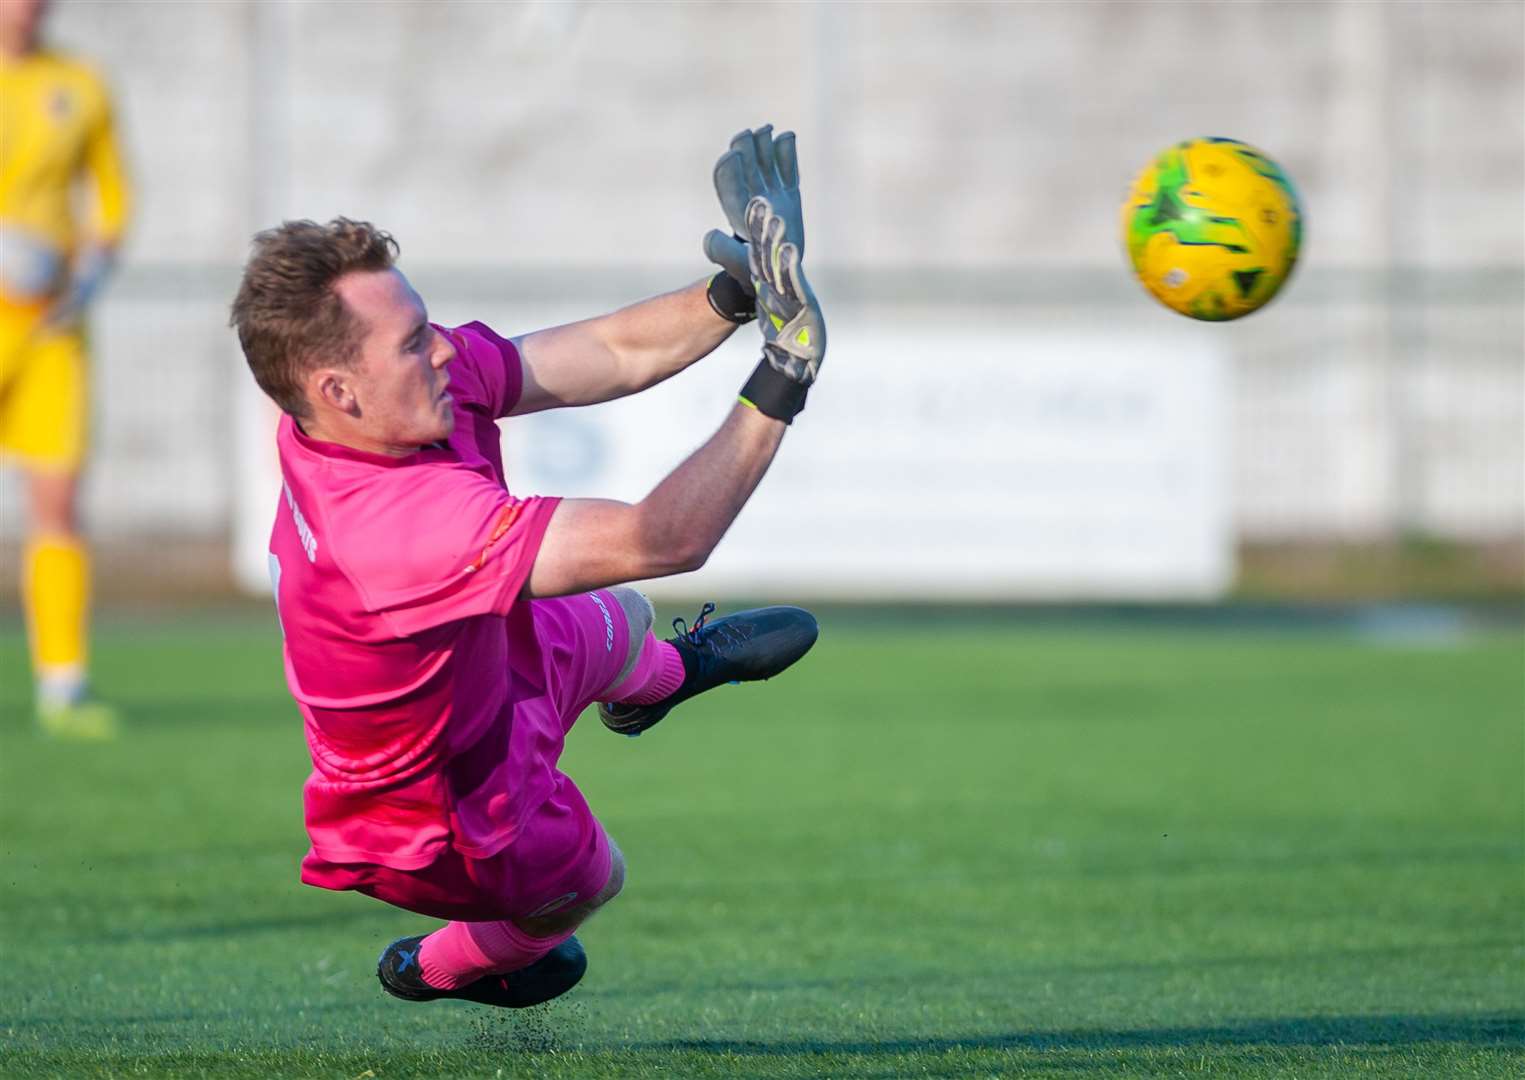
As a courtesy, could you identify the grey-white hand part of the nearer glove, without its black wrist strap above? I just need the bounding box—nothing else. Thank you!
[747,195,827,386]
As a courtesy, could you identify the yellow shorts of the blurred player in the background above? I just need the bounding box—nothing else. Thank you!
[0,299,90,471]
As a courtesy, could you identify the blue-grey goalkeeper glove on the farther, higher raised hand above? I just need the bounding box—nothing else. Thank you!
[705,124,805,310]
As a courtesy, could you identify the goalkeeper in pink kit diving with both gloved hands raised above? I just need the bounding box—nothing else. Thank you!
[232,127,825,1008]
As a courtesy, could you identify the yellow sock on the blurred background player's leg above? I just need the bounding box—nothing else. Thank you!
[21,535,90,685]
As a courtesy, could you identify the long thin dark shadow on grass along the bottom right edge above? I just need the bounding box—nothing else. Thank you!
[646,1013,1525,1057]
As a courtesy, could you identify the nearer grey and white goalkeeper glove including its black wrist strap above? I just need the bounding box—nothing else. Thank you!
[741,195,827,424]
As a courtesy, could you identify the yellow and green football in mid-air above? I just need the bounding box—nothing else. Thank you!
[1122,137,1302,322]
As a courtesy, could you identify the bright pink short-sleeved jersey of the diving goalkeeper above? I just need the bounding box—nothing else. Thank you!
[270,322,560,869]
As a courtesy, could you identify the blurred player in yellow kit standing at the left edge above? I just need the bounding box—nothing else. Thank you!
[0,0,128,738]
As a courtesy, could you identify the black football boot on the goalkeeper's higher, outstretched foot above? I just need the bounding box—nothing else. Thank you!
[598,604,819,735]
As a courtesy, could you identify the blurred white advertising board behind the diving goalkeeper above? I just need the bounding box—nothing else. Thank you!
[236,313,1234,601]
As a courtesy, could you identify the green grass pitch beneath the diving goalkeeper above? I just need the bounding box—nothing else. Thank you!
[0,613,1525,1080]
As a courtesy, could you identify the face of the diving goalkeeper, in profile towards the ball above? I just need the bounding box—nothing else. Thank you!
[334,270,456,455]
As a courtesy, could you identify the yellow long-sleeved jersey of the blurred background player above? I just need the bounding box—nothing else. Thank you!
[0,49,130,280]
